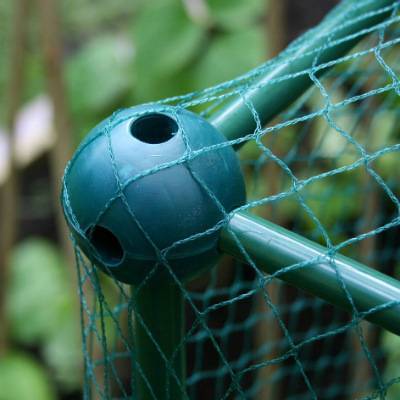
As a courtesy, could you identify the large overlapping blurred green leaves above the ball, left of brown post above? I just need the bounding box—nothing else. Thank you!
[132,0,267,103]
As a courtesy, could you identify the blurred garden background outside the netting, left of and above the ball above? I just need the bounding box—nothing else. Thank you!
[0,0,400,400]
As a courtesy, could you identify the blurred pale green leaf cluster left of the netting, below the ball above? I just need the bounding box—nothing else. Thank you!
[6,238,82,399]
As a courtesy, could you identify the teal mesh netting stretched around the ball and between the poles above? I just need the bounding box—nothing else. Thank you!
[65,1,400,400]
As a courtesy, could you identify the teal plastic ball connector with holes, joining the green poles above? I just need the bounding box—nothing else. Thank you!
[61,105,246,285]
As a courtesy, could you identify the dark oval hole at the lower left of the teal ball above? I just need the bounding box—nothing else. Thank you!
[87,225,124,265]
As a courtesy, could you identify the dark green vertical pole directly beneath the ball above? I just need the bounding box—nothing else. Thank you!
[132,283,187,400]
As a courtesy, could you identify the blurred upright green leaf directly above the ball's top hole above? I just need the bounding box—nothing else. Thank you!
[133,0,205,102]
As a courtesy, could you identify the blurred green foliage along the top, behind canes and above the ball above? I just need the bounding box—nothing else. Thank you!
[0,0,268,136]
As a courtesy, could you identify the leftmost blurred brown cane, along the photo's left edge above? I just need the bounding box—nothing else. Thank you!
[0,0,29,355]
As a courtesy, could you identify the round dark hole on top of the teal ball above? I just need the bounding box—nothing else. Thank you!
[130,113,179,144]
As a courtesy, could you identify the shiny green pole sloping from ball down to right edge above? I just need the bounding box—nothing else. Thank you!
[220,212,400,335]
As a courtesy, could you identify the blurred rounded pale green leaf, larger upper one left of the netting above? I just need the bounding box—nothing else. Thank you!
[7,239,72,344]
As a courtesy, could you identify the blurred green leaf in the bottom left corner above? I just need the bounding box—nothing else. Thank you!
[0,354,56,400]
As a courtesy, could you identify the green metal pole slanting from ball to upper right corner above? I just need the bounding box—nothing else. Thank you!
[210,0,396,140]
